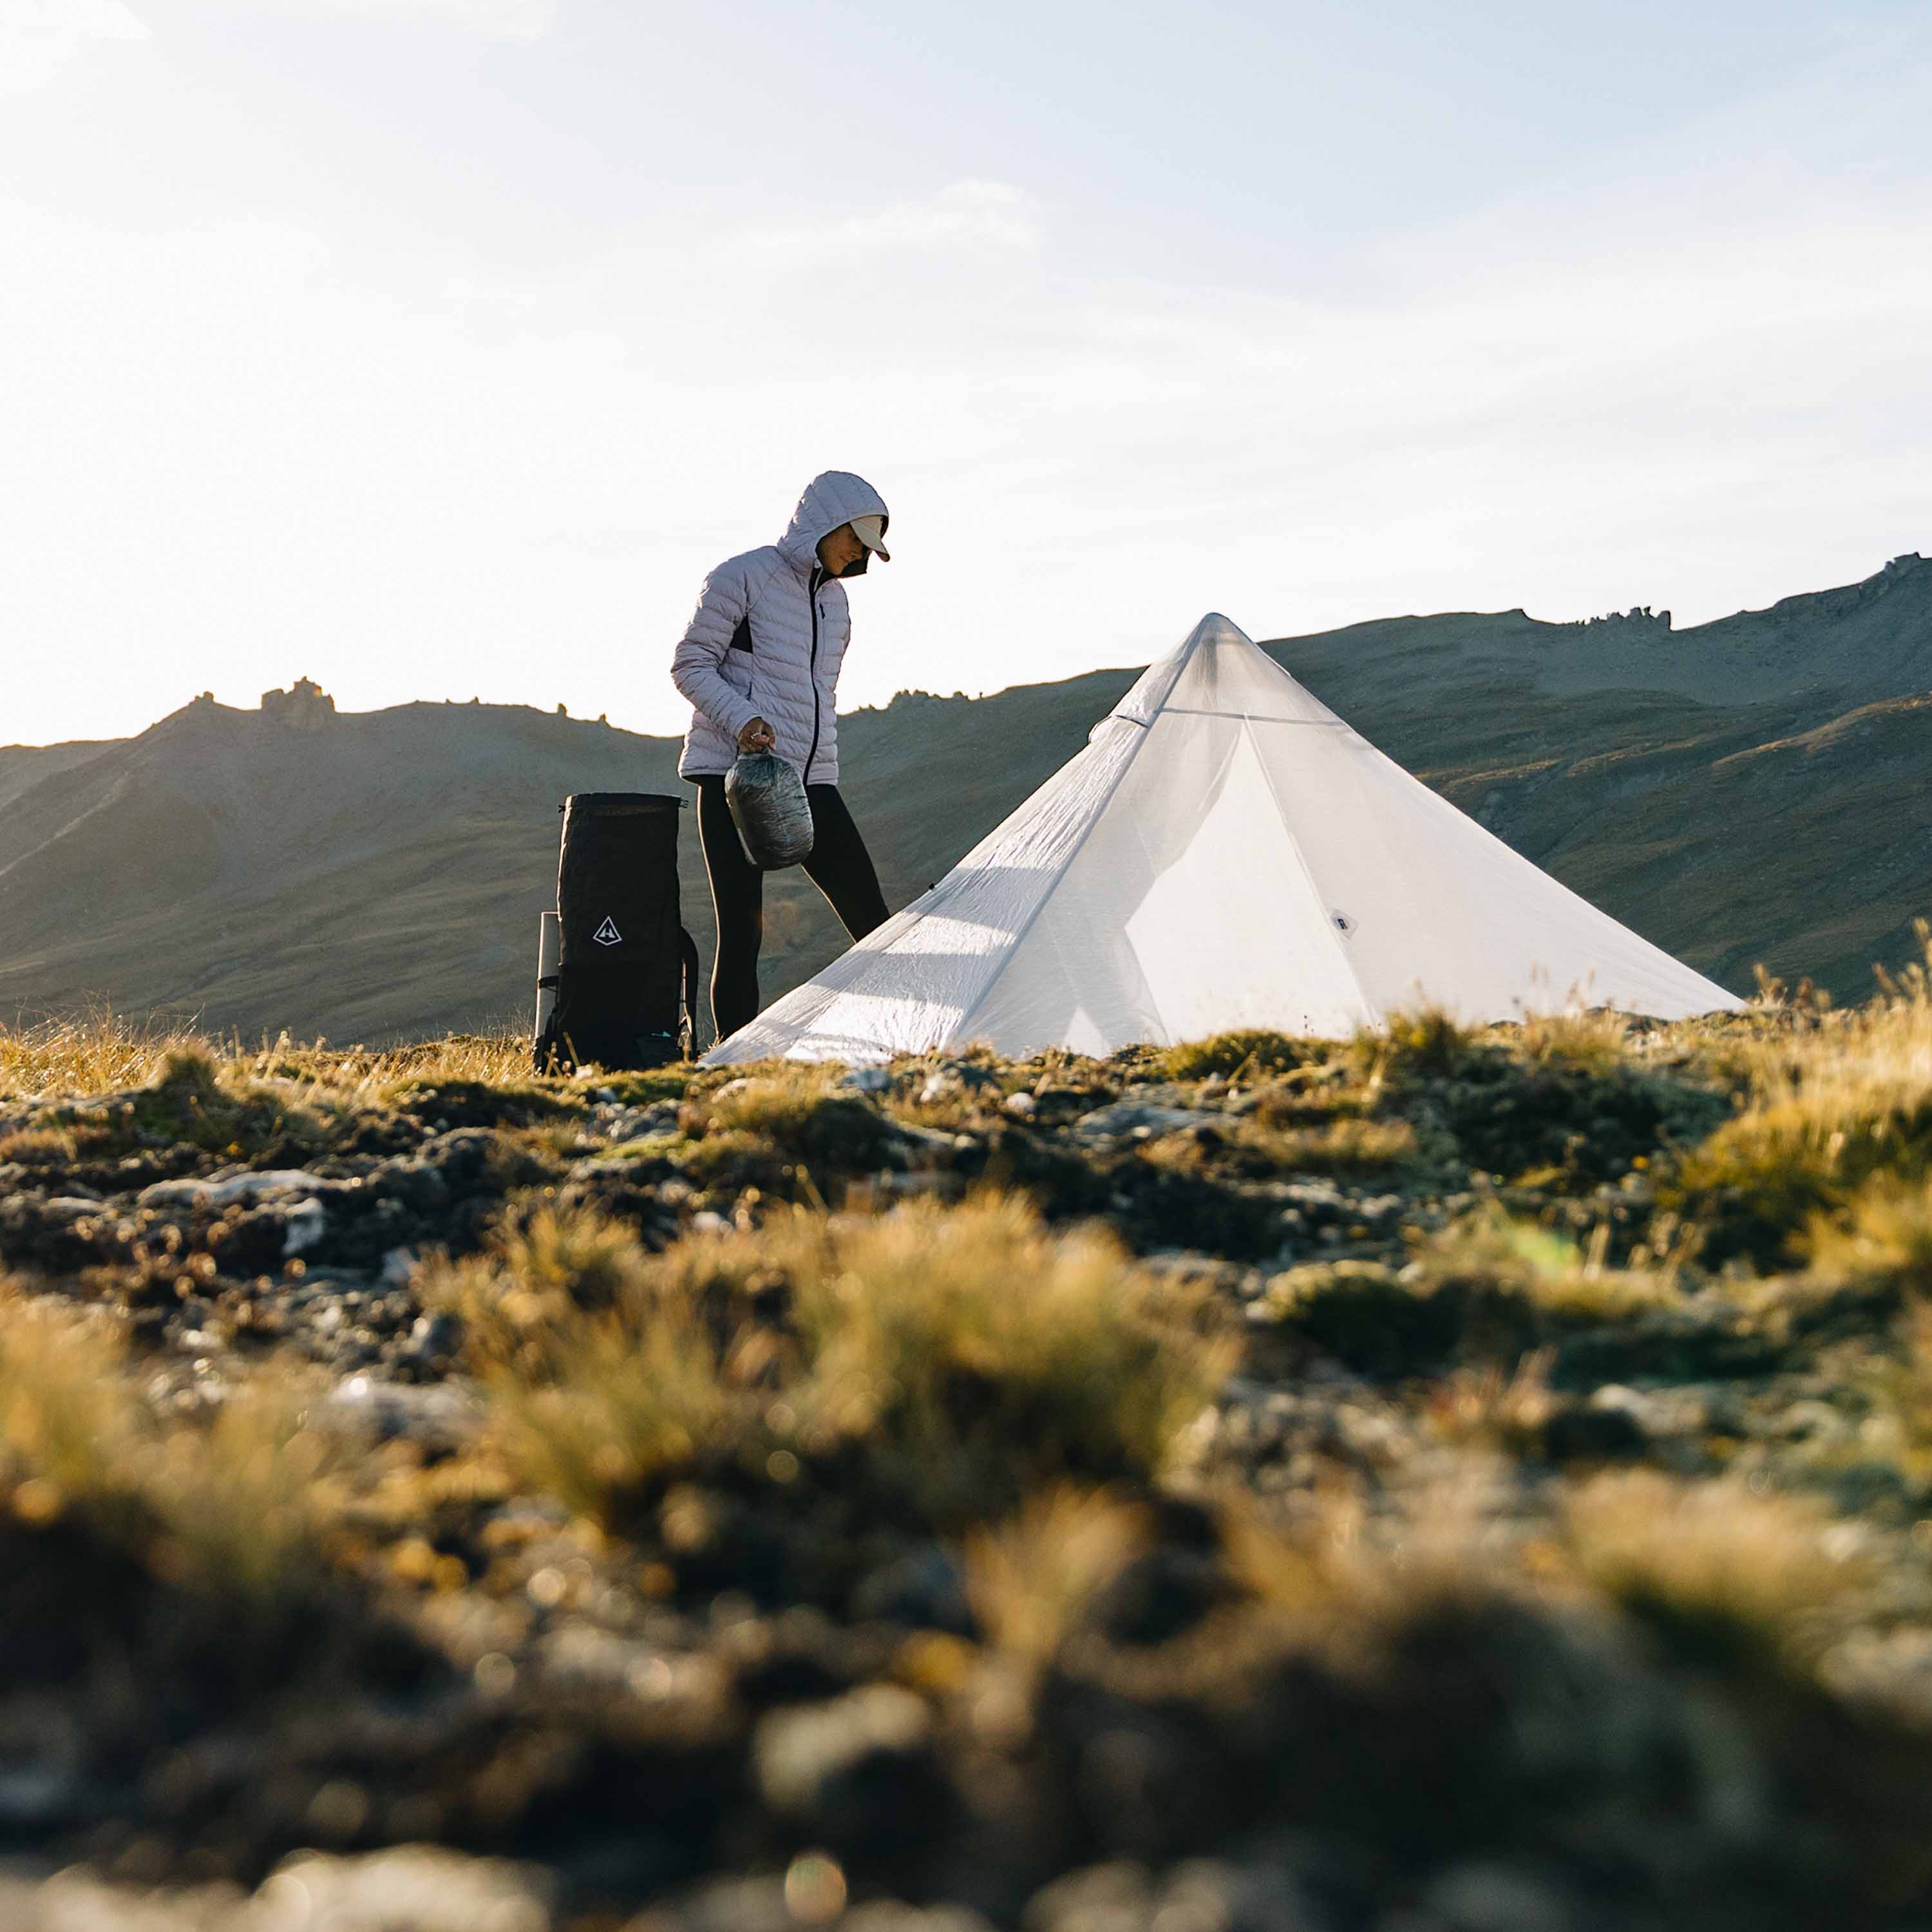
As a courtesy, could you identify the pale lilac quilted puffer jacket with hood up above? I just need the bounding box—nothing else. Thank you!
[670,469,887,784]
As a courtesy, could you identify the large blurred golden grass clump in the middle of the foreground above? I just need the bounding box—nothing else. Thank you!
[435,1196,1235,1522]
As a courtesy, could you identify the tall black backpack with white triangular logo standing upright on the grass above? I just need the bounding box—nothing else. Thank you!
[535,792,697,1072]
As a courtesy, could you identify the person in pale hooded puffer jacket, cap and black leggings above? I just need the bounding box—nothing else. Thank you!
[670,469,891,1039]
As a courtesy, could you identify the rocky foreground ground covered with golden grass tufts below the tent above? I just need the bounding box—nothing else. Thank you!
[15,976,1932,1932]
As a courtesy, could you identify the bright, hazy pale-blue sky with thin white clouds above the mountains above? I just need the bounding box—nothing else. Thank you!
[0,0,1932,744]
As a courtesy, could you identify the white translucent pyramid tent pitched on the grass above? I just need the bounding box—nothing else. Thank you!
[707,616,1741,1065]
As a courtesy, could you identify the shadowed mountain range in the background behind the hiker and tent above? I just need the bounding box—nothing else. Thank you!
[0,558,1932,1039]
